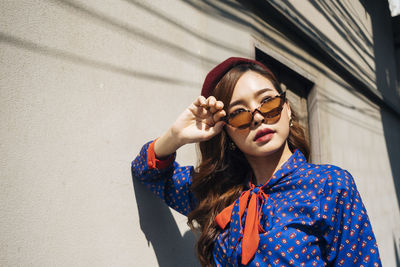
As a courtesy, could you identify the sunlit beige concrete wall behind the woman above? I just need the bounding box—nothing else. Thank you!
[0,0,400,266]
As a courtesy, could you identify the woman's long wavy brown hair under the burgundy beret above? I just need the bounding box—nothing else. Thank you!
[188,63,309,267]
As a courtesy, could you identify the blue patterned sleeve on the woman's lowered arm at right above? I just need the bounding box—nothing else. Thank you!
[321,169,381,266]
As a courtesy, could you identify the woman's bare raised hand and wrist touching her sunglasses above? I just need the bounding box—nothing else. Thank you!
[154,96,226,158]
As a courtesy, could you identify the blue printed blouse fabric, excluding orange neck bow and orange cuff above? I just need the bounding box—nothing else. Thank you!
[132,143,381,267]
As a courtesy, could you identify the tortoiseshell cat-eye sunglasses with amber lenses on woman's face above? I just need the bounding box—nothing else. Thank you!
[223,92,286,129]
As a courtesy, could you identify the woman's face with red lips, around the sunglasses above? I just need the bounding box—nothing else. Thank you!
[226,71,291,157]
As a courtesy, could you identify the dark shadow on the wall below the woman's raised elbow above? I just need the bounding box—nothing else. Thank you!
[133,179,200,267]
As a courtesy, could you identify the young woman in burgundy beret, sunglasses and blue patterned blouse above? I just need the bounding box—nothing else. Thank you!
[132,58,381,266]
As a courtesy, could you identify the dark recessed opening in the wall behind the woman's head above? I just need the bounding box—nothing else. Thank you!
[256,48,314,147]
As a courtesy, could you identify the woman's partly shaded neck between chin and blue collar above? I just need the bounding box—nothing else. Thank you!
[246,142,293,185]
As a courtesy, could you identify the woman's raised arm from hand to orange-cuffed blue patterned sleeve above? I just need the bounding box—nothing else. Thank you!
[132,96,225,215]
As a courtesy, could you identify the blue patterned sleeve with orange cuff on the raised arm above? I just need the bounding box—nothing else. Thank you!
[131,141,196,215]
